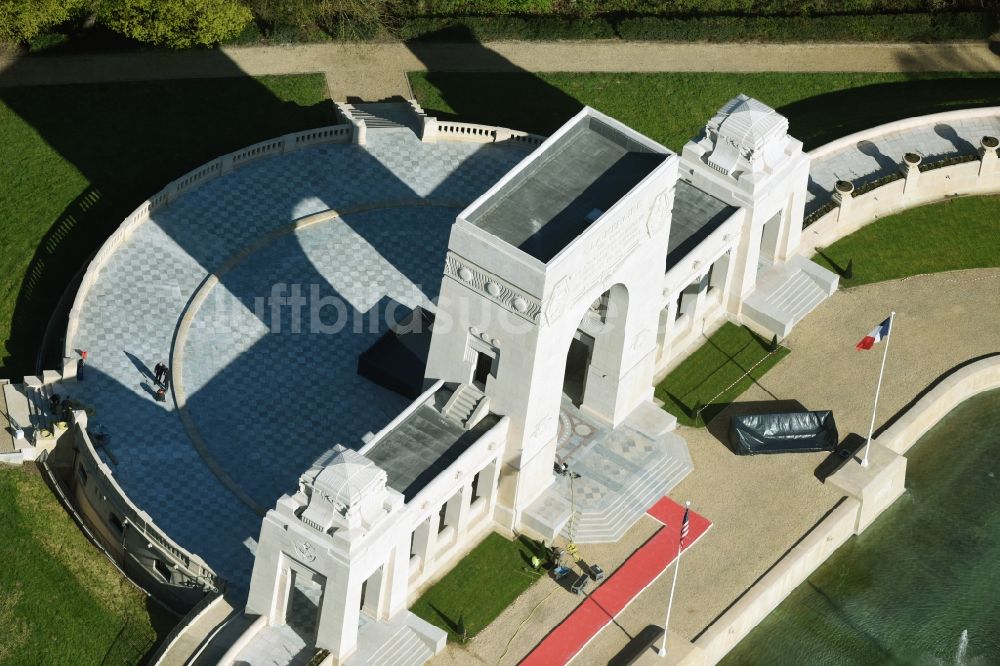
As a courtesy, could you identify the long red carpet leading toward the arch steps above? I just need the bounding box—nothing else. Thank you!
[521,497,712,666]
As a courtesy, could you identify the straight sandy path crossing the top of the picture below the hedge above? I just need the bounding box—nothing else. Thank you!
[0,41,1000,100]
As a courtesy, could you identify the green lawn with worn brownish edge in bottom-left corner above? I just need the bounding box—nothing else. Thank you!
[0,465,169,665]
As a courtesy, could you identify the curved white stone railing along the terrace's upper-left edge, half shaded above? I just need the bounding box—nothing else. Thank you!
[63,124,354,356]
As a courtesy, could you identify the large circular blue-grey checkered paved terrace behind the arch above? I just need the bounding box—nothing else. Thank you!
[69,129,530,598]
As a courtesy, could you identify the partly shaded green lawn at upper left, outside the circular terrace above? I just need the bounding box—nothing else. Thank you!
[0,69,334,378]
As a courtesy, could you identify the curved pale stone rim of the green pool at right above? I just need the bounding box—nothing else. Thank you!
[875,354,1000,454]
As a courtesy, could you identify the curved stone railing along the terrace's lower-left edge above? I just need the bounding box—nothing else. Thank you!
[73,412,225,592]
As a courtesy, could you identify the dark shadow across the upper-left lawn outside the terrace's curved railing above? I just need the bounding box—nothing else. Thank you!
[0,51,335,377]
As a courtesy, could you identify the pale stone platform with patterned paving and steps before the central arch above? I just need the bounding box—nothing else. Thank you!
[523,398,694,543]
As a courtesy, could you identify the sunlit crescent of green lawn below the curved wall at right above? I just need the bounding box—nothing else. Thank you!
[814,192,1000,287]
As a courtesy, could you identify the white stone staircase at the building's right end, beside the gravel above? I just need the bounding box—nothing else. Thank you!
[743,256,840,338]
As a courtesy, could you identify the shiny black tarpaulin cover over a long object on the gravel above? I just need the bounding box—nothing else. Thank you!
[729,411,838,456]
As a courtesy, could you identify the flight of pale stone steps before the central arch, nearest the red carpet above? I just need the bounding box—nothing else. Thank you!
[560,438,692,543]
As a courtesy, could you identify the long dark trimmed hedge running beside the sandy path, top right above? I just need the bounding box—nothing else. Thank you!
[399,12,997,42]
